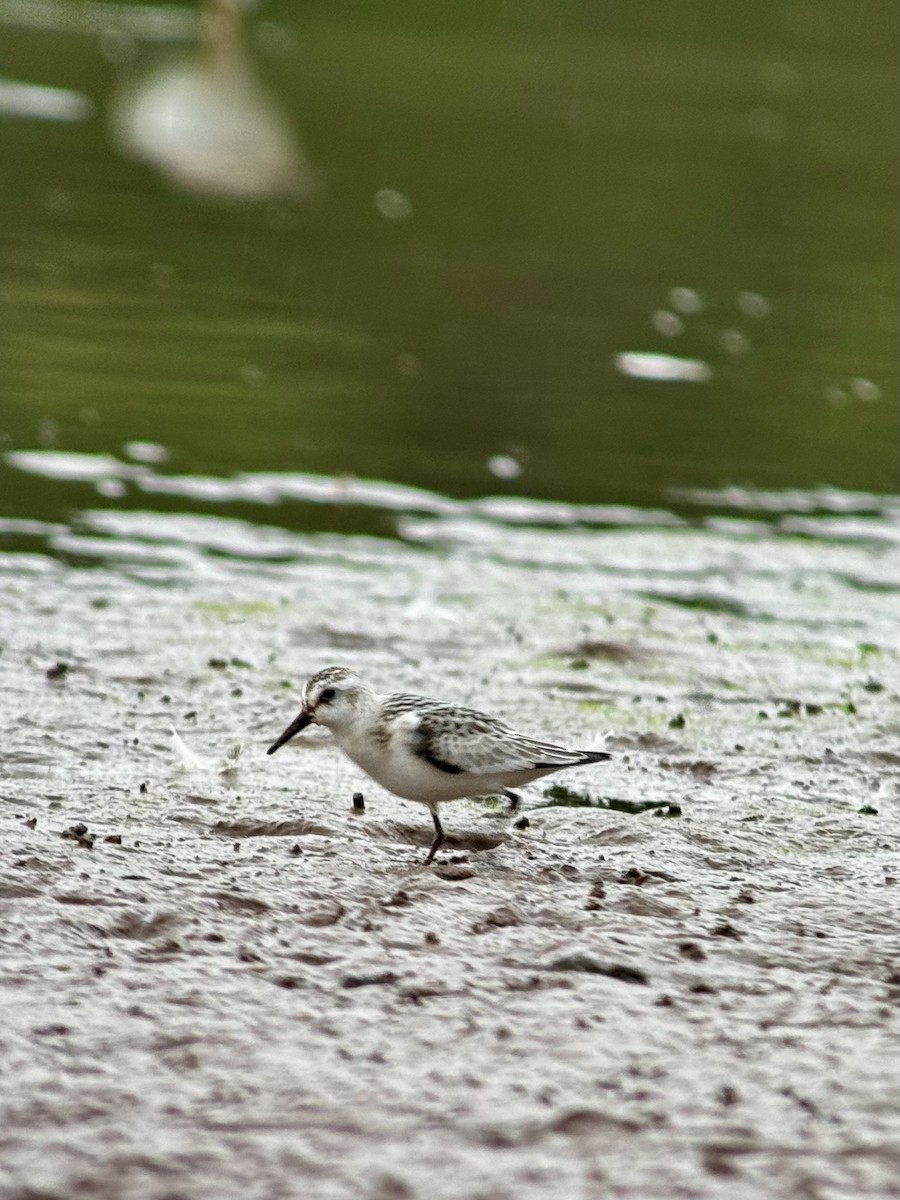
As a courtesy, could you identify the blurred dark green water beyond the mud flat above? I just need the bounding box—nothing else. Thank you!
[0,0,898,527]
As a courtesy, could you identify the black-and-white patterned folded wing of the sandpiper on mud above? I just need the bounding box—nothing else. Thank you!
[391,696,610,775]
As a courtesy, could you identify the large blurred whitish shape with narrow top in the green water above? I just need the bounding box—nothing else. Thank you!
[113,0,317,200]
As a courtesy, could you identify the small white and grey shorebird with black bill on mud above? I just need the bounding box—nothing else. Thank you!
[266,666,612,866]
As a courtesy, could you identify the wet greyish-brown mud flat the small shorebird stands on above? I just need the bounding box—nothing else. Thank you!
[0,515,900,1200]
